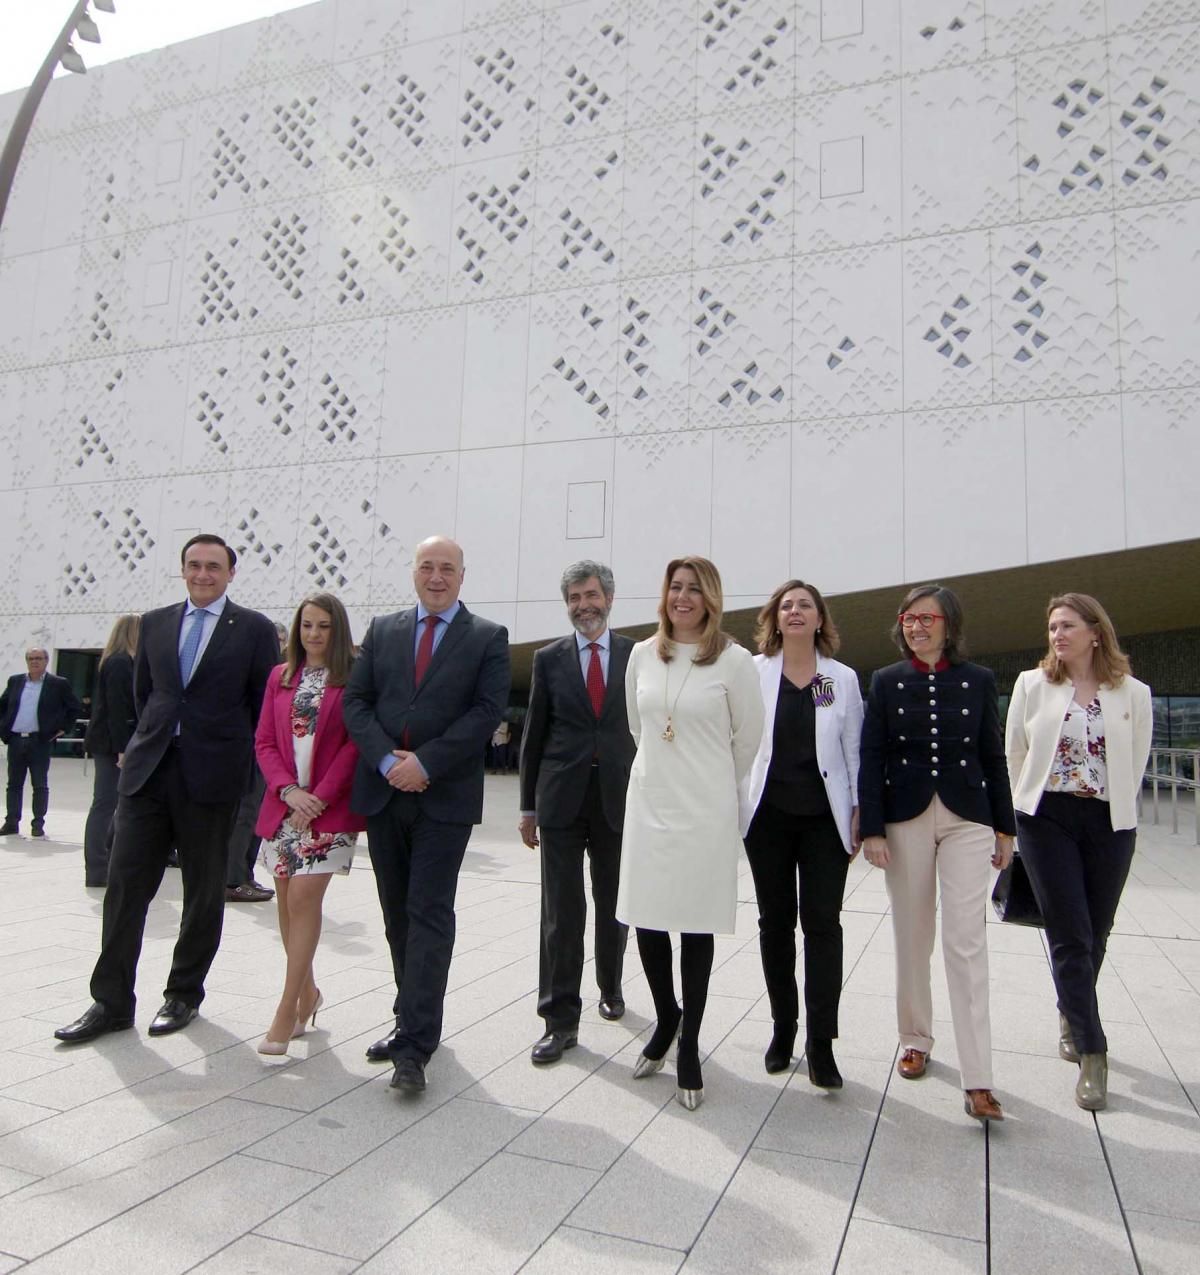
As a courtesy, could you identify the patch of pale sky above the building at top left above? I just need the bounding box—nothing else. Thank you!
[0,0,312,93]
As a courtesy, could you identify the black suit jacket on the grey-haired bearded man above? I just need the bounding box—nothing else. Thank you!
[520,632,638,831]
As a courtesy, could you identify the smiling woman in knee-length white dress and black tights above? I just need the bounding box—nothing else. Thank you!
[617,557,763,1111]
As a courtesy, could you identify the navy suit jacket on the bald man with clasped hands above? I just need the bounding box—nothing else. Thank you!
[342,606,511,824]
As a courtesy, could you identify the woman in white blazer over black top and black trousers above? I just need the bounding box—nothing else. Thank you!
[738,580,862,1089]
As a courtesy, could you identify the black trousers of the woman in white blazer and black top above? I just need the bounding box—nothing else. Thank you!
[746,802,849,1040]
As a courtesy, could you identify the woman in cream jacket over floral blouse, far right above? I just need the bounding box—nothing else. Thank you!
[1005,593,1152,1111]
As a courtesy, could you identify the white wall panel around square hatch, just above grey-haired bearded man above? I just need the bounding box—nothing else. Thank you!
[516,439,617,599]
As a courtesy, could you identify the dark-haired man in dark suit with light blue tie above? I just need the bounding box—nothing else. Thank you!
[55,534,279,1044]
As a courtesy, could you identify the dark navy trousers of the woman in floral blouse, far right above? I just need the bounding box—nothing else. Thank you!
[1016,793,1136,1053]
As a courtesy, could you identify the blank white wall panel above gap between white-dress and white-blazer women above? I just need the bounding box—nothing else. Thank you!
[712,425,792,598]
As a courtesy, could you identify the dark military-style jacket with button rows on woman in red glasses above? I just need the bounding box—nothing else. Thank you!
[858,659,1016,836]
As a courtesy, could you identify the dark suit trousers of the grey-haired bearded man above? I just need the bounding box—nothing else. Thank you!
[537,766,629,1031]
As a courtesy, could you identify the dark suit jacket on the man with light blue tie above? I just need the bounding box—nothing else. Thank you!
[117,599,279,805]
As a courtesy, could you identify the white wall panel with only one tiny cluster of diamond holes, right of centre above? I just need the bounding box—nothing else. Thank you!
[793,244,903,417]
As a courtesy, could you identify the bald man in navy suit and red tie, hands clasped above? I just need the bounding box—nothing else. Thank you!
[343,536,510,1093]
